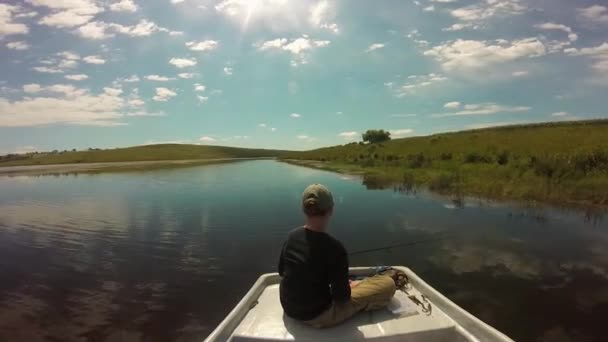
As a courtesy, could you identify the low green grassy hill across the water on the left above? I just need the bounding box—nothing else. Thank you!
[0,144,283,167]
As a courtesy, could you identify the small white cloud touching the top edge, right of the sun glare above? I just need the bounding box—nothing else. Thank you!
[450,0,526,22]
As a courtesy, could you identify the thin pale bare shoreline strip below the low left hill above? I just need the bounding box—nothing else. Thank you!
[0,157,274,177]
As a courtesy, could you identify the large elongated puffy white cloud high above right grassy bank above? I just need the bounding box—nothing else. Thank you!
[424,38,547,71]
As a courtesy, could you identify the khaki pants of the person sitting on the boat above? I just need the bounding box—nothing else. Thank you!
[304,275,396,328]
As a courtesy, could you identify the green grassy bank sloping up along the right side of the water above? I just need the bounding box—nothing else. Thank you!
[282,120,608,206]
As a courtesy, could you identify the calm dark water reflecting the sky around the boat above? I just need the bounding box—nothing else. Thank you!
[0,161,608,341]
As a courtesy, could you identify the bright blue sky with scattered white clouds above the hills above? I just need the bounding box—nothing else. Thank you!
[0,0,608,153]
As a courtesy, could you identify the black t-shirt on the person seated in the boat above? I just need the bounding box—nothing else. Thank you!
[279,228,350,320]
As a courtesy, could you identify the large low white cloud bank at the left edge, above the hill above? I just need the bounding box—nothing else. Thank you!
[0,84,159,127]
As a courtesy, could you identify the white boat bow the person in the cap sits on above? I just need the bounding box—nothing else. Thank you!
[205,266,512,342]
